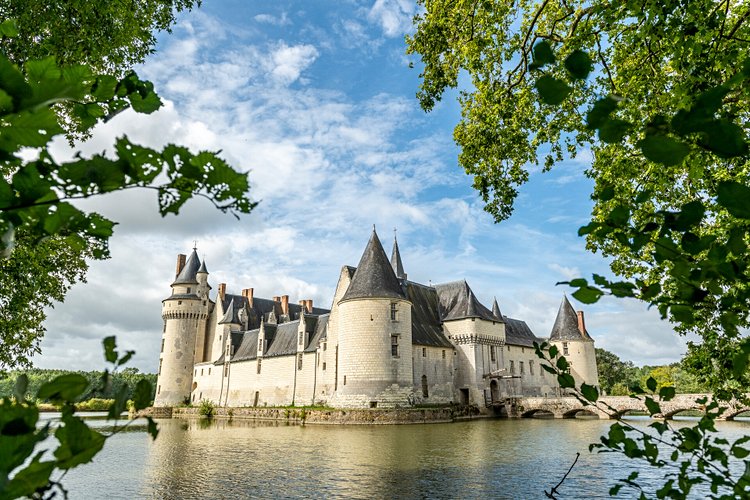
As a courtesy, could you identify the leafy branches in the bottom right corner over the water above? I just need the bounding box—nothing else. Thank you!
[534,343,750,498]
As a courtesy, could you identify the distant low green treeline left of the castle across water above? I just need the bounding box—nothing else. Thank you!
[0,368,156,403]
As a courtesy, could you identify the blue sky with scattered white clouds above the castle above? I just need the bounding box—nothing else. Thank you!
[34,0,684,371]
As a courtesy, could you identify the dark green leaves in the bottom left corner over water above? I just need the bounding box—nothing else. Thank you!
[0,337,158,499]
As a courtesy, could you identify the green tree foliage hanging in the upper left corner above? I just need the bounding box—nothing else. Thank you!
[0,0,254,371]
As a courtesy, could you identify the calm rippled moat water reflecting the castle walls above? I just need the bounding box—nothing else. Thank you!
[38,412,750,499]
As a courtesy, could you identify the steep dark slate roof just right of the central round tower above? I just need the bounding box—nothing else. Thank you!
[405,281,453,348]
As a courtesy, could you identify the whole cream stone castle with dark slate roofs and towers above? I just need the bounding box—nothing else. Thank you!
[154,228,599,411]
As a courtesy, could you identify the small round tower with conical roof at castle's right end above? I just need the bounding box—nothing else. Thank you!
[549,297,599,387]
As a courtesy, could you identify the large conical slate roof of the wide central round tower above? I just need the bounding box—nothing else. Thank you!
[341,228,405,301]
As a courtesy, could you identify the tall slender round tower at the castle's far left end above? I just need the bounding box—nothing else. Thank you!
[154,249,208,406]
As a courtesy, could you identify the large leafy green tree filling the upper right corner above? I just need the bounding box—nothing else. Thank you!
[407,0,750,395]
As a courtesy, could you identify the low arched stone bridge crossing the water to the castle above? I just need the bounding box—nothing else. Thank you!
[500,394,750,420]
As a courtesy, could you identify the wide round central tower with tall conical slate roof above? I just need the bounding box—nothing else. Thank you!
[335,228,413,407]
